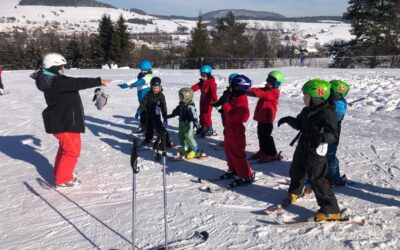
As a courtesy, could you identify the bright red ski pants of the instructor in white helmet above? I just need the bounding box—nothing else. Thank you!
[53,132,81,185]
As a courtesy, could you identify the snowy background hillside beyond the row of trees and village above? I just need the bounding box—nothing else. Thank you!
[0,0,352,50]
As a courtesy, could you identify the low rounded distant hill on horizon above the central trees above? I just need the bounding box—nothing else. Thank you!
[203,9,286,20]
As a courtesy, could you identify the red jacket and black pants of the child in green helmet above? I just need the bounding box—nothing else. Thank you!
[248,87,280,156]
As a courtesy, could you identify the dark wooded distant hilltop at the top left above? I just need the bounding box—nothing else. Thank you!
[19,0,116,9]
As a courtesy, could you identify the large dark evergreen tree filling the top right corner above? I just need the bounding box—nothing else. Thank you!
[344,0,400,68]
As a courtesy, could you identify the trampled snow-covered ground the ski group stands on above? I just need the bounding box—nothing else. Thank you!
[0,68,400,249]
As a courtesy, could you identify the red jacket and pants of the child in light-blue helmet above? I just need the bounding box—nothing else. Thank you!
[192,77,218,128]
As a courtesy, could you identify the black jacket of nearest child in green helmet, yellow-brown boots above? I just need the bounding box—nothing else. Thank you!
[296,103,338,148]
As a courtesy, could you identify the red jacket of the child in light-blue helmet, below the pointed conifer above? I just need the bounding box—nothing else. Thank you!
[192,77,218,110]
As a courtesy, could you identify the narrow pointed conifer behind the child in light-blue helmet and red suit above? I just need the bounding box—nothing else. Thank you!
[186,13,211,68]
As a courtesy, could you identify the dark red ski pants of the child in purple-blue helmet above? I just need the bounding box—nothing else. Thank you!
[224,126,251,178]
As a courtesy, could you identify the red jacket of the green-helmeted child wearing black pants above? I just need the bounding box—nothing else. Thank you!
[248,87,280,124]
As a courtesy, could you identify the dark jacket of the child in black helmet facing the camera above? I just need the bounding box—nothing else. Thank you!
[139,89,167,120]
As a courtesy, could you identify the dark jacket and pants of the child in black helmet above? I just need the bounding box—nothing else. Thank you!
[139,89,171,145]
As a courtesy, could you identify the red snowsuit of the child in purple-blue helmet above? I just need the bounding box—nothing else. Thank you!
[222,94,252,178]
